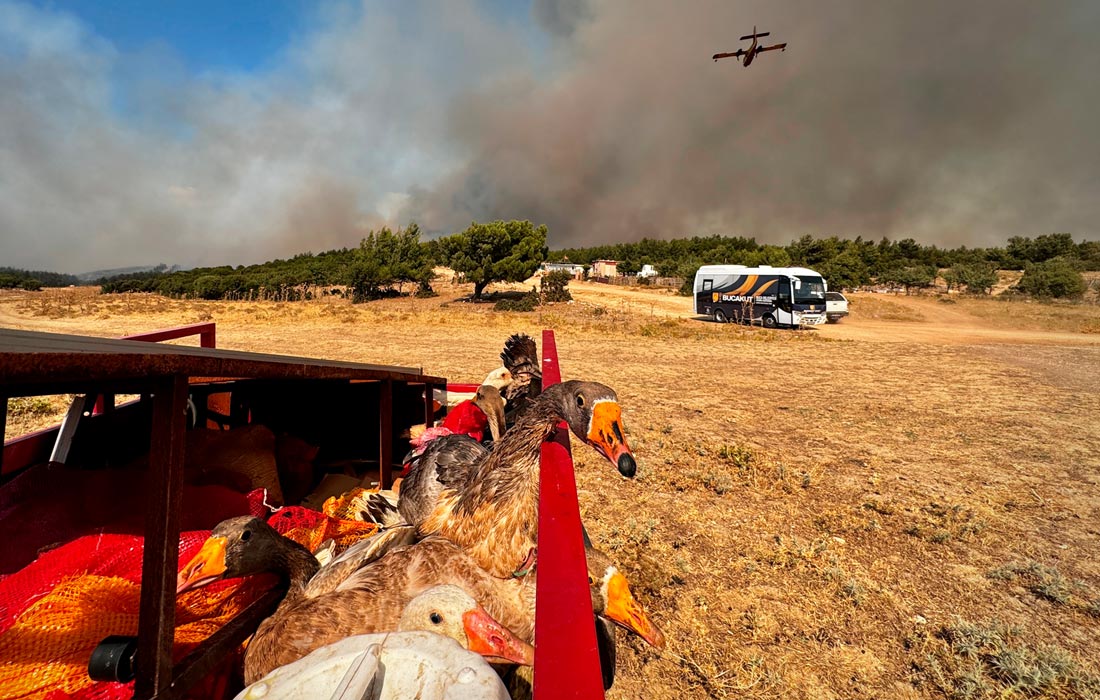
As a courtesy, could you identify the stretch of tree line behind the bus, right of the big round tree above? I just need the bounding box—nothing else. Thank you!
[551,233,1100,296]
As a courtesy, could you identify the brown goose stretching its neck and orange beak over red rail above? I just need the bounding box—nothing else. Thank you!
[397,381,637,578]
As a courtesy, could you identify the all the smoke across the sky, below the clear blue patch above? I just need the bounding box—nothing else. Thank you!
[0,0,1100,272]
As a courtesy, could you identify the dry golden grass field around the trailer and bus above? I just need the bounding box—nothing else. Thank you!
[0,284,1100,699]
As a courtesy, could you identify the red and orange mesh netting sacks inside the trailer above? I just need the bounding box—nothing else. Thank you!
[0,493,376,700]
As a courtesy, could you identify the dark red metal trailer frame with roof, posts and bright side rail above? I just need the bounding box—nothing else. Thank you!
[0,324,604,700]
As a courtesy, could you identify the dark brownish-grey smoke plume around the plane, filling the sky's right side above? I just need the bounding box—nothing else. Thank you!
[418,1,1100,249]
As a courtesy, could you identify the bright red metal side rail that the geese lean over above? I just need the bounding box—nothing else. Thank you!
[535,330,604,700]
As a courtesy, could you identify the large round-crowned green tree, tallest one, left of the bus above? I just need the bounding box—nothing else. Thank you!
[438,221,547,298]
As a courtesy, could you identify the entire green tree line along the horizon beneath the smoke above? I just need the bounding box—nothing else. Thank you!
[0,227,1100,302]
